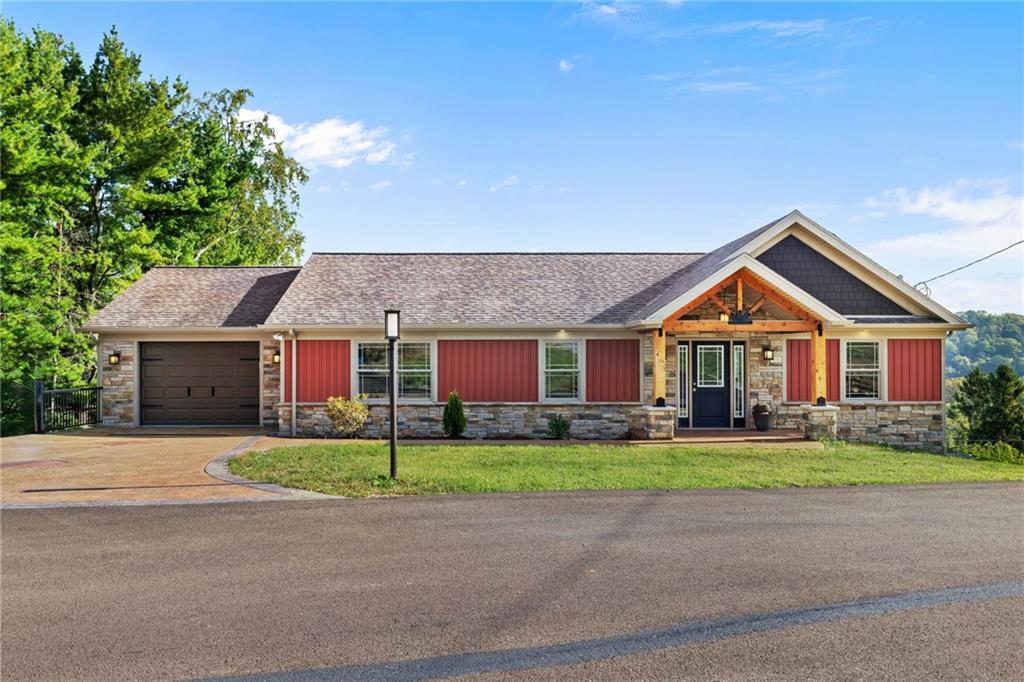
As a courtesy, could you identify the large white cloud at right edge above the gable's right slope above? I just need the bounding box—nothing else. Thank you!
[864,179,1024,259]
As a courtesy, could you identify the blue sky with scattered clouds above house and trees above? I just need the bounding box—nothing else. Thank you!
[4,2,1024,311]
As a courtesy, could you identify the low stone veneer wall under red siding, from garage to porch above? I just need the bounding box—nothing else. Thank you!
[278,402,651,440]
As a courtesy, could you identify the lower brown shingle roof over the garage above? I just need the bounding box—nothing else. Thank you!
[84,267,299,331]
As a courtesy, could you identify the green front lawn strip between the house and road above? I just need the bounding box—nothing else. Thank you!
[229,441,1024,498]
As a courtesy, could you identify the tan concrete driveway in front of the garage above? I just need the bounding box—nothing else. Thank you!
[0,428,274,508]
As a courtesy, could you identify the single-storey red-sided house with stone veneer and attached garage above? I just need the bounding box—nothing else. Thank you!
[84,211,970,451]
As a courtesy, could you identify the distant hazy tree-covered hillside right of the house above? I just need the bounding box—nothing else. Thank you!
[946,310,1024,378]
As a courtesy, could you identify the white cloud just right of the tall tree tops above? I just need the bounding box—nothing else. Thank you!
[239,109,403,168]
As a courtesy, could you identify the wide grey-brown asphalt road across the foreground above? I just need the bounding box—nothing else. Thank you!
[0,483,1024,680]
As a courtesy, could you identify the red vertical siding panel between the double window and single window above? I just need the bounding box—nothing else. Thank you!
[437,340,538,402]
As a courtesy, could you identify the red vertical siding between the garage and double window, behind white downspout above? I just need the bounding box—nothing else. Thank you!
[282,339,352,402]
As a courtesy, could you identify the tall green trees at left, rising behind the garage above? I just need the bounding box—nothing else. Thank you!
[0,20,306,432]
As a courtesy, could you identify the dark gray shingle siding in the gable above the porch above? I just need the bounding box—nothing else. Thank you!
[758,235,910,315]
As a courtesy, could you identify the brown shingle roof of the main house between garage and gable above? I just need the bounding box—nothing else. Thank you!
[266,253,699,327]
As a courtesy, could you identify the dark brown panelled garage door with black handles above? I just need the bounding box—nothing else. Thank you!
[139,342,259,425]
